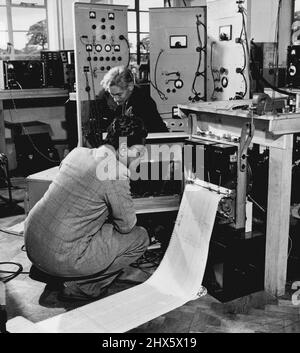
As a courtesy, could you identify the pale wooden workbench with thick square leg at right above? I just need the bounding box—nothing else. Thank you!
[178,100,300,296]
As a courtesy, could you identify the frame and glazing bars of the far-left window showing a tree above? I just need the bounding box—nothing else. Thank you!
[0,0,49,60]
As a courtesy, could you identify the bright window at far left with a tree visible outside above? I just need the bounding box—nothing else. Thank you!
[0,0,48,60]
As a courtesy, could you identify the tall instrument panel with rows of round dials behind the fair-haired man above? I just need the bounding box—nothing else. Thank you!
[73,2,129,145]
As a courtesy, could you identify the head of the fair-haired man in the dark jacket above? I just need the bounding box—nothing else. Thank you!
[101,66,134,105]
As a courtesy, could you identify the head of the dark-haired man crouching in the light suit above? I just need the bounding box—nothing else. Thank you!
[104,115,147,166]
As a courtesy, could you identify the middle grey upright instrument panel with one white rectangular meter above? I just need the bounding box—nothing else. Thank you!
[150,6,207,118]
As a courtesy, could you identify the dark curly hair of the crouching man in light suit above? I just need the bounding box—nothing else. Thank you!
[104,115,148,150]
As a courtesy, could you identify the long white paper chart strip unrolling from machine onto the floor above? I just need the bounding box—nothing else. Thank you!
[7,184,221,333]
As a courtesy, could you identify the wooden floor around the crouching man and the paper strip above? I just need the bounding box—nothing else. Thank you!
[0,180,300,333]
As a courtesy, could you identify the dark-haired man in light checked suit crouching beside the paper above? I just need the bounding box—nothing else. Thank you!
[24,116,149,300]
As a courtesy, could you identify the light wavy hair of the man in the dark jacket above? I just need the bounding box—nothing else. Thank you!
[101,66,134,91]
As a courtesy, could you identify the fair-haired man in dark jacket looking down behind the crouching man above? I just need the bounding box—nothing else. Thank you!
[96,66,169,133]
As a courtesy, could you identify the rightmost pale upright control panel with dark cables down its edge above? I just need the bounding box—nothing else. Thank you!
[207,0,250,101]
